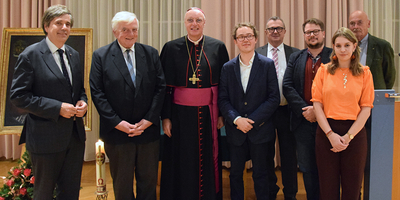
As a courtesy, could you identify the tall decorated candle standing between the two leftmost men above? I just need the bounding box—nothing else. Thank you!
[96,140,107,195]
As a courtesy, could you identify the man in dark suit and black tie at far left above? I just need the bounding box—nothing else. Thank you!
[10,5,87,200]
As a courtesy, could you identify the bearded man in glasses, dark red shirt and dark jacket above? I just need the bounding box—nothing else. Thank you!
[282,18,332,200]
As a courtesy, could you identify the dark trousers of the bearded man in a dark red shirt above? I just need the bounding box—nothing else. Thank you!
[293,118,319,200]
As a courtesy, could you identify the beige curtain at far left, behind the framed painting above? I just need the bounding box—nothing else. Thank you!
[0,0,65,159]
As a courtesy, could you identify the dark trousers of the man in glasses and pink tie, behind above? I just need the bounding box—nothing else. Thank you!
[267,106,297,200]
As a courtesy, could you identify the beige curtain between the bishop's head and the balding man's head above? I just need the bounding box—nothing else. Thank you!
[201,0,364,58]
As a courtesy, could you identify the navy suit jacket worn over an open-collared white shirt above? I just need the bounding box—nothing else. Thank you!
[218,52,280,146]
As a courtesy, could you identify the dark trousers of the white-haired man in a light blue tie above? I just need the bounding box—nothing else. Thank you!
[104,140,160,200]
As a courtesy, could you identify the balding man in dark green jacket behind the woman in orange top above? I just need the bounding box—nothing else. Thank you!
[349,10,396,89]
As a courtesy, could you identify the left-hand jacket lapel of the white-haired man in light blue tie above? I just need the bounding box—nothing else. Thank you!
[110,40,135,91]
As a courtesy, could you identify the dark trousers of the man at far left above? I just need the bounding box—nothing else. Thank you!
[29,129,85,200]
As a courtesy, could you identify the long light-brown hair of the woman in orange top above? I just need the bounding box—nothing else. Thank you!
[328,27,363,76]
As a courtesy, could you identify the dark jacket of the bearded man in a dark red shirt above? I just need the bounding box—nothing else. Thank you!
[282,47,332,131]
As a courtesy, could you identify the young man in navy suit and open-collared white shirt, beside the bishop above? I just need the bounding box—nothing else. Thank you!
[218,23,279,200]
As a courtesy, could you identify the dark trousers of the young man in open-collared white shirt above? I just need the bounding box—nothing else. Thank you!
[229,139,269,200]
